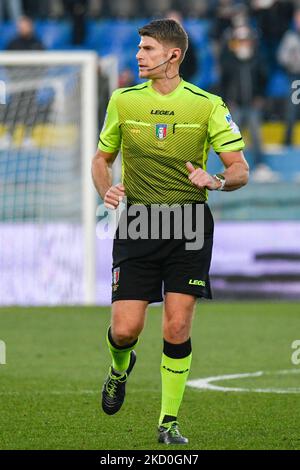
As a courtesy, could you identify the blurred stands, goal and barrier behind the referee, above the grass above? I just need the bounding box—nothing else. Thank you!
[0,0,300,305]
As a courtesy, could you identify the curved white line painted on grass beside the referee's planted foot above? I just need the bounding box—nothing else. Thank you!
[187,369,300,394]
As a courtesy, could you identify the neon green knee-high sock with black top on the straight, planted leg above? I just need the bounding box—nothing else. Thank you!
[159,339,192,425]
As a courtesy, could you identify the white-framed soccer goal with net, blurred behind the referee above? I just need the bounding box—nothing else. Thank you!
[0,52,117,305]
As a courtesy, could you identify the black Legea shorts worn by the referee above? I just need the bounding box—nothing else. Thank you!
[112,203,214,303]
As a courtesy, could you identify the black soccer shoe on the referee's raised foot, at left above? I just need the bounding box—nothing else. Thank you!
[102,351,136,415]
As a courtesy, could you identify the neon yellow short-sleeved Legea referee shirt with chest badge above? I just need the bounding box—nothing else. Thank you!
[98,80,245,205]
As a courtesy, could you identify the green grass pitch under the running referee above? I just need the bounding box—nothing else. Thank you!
[0,302,300,450]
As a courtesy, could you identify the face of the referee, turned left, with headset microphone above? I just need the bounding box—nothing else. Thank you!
[136,36,172,79]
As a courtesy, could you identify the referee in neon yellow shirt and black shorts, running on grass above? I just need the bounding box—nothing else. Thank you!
[92,19,249,444]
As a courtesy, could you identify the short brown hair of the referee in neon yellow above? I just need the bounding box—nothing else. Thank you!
[139,19,189,62]
